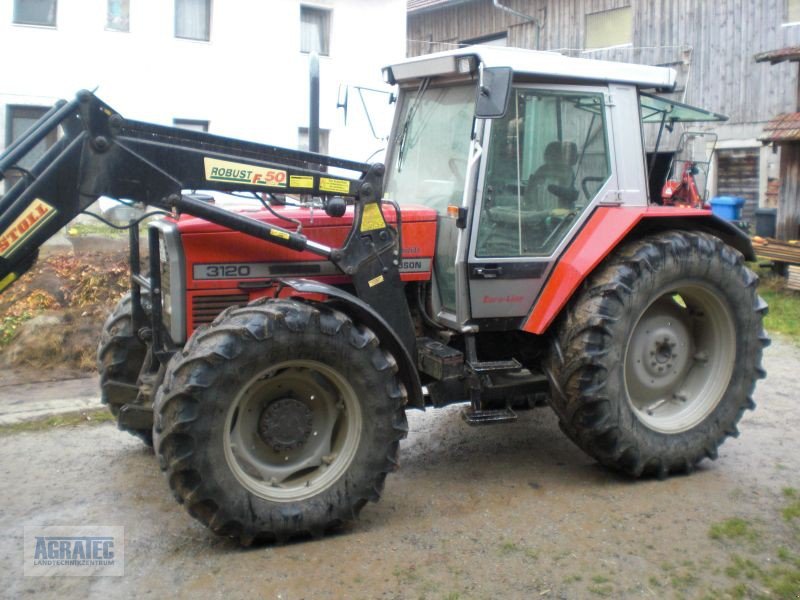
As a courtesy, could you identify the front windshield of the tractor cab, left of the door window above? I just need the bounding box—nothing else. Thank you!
[386,85,475,214]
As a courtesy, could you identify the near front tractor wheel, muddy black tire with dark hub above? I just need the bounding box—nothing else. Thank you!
[154,299,408,546]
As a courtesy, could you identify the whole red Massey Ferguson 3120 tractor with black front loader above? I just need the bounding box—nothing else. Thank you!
[0,47,769,544]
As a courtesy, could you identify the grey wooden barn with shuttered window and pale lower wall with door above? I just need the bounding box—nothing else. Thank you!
[407,0,800,220]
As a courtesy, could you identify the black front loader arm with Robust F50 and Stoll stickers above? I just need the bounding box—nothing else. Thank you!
[0,91,414,348]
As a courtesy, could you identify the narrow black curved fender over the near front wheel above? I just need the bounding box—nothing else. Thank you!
[280,279,425,410]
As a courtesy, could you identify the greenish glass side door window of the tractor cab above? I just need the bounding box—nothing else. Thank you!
[476,89,611,257]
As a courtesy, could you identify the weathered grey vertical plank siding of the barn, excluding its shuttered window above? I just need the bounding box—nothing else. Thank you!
[407,0,800,125]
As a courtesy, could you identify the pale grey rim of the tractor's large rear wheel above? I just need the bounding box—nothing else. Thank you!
[624,282,736,434]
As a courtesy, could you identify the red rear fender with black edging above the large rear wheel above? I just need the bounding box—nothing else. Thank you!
[521,206,755,334]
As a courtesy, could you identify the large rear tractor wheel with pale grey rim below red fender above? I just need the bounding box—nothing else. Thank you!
[547,231,769,479]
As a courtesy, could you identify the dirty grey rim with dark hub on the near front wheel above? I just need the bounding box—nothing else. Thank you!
[223,360,362,502]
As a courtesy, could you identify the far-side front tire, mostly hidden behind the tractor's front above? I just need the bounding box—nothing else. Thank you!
[97,293,153,446]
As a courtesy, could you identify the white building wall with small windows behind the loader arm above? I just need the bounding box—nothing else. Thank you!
[0,0,406,160]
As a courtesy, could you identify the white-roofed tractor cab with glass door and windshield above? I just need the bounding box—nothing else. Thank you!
[384,46,724,330]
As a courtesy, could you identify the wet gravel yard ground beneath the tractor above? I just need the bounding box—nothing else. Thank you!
[0,340,800,600]
